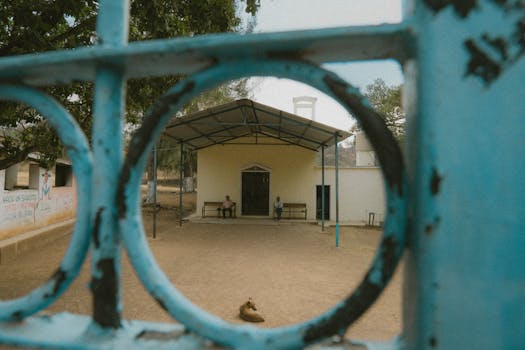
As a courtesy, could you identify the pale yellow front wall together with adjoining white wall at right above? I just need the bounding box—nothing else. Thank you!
[197,138,385,224]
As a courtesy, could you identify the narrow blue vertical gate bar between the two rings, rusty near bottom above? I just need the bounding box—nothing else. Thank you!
[91,0,128,328]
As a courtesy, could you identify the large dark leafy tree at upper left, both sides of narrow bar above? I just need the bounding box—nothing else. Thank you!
[0,0,260,169]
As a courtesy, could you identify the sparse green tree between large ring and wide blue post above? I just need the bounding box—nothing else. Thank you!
[352,79,405,143]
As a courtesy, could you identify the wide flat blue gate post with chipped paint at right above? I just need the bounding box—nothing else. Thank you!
[403,1,525,350]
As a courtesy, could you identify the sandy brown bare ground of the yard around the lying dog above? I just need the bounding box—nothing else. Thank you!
[0,191,402,340]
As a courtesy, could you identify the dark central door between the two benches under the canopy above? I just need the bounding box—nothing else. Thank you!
[242,172,270,215]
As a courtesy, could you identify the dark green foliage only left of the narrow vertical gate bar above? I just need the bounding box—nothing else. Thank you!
[0,0,97,169]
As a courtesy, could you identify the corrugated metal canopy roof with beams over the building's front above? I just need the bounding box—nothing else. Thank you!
[164,99,350,151]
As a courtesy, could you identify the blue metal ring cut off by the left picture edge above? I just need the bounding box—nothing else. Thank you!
[0,84,93,321]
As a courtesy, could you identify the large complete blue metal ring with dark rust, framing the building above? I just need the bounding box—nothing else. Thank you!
[116,60,407,349]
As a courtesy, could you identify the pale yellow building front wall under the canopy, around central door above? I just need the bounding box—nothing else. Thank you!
[197,139,315,218]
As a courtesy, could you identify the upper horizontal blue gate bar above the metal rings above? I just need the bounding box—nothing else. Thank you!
[0,23,414,85]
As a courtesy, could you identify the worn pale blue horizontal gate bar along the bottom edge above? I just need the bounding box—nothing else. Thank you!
[0,312,399,350]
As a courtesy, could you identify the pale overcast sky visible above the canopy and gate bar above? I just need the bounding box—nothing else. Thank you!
[245,0,403,130]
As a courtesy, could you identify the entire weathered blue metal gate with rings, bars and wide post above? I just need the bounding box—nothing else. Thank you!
[0,0,525,349]
